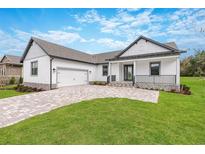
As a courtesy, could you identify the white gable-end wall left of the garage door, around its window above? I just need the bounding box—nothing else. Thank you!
[23,43,50,84]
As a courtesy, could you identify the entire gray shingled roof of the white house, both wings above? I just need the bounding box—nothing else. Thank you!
[21,36,184,64]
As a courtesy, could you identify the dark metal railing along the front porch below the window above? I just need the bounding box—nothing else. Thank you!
[134,75,176,85]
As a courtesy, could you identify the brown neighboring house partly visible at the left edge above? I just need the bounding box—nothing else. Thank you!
[0,55,23,85]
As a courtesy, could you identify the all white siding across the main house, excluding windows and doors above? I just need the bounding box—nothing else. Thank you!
[23,40,180,87]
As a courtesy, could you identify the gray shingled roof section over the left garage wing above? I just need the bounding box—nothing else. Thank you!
[21,37,120,64]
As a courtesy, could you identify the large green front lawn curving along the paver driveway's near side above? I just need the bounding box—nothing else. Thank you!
[0,78,205,144]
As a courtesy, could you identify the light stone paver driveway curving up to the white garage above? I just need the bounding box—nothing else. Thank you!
[0,85,159,127]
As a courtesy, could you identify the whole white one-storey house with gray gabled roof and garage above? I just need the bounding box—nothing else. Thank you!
[21,36,185,90]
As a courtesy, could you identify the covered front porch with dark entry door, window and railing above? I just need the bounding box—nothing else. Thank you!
[108,56,180,90]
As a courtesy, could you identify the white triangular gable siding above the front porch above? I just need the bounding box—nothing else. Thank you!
[120,39,169,57]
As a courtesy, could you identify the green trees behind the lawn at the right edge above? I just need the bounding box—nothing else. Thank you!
[180,50,205,76]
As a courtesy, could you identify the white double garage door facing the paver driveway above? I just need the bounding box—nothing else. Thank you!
[57,69,88,87]
